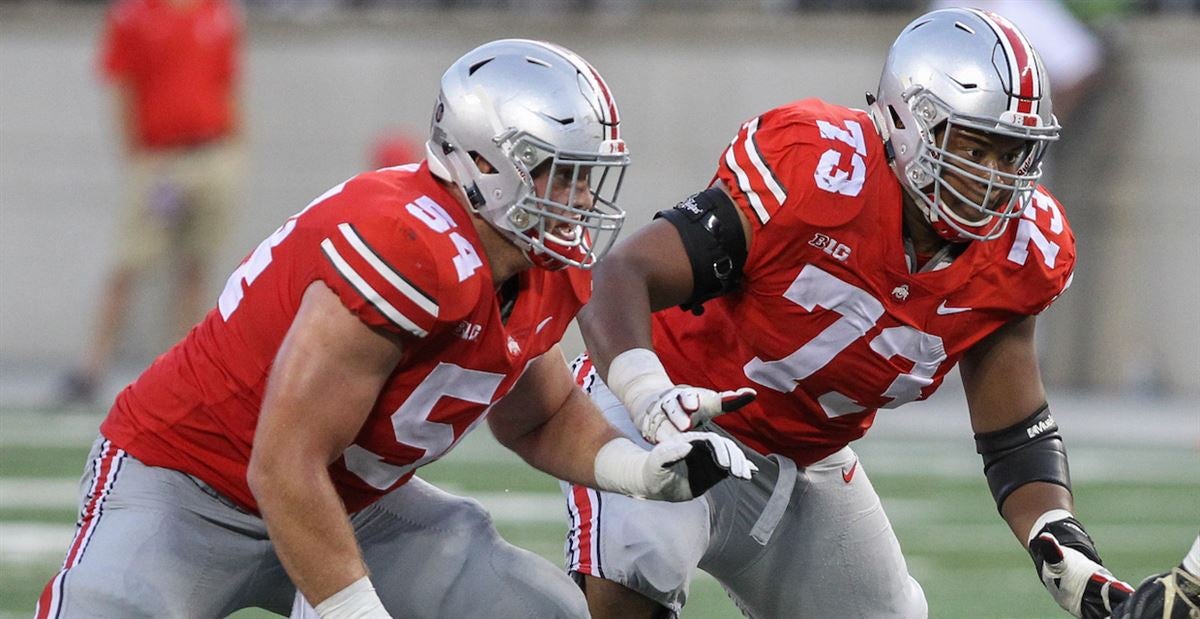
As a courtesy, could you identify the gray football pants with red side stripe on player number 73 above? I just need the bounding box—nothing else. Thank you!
[562,378,928,619]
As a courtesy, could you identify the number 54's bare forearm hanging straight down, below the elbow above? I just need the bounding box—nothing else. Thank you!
[248,458,367,606]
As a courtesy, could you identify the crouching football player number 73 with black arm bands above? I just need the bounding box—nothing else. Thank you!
[565,10,1129,619]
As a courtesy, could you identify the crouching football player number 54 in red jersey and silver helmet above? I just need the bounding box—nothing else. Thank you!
[38,40,752,619]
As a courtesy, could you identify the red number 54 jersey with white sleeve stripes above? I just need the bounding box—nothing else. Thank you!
[101,163,592,511]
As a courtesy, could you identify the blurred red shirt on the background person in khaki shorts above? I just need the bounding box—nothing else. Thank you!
[100,0,241,149]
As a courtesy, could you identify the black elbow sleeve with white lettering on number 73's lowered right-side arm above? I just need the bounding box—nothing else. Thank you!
[976,404,1070,510]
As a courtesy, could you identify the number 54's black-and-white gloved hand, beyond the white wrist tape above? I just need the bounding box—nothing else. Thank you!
[642,432,758,501]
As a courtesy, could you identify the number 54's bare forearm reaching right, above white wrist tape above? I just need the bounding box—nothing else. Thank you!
[497,390,620,487]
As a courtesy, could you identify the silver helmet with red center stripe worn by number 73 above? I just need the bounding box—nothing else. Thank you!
[871,8,1060,241]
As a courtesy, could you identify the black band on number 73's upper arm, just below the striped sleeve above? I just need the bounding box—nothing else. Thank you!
[654,187,746,314]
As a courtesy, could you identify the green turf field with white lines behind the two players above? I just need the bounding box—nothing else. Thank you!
[0,411,1200,619]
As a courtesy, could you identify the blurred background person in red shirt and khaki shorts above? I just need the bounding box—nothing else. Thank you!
[60,0,244,405]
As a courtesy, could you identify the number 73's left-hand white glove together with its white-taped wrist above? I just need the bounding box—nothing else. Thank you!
[606,348,758,443]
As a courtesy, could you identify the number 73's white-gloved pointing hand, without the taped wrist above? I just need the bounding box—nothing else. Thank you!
[632,385,758,443]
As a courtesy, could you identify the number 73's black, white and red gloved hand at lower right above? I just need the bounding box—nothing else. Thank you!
[1030,510,1133,619]
